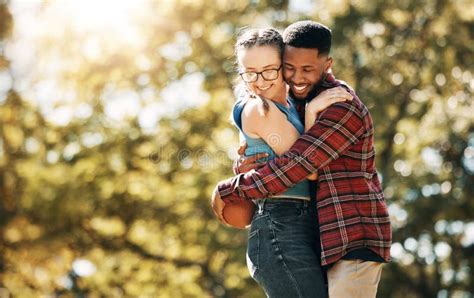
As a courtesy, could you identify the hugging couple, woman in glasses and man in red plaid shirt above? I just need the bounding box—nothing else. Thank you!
[211,21,391,297]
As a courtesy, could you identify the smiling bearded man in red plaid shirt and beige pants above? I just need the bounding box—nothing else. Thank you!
[213,21,391,297]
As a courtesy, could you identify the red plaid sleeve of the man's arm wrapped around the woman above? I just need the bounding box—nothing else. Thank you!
[217,102,367,203]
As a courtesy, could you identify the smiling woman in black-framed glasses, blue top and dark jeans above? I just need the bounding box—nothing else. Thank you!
[224,29,345,297]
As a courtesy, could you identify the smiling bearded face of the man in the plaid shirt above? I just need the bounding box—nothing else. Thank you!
[283,46,332,100]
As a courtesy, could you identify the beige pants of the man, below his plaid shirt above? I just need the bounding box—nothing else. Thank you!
[328,260,383,298]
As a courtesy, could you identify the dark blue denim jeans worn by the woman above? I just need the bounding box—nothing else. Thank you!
[247,199,328,298]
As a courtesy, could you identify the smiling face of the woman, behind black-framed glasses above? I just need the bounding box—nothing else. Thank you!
[238,46,286,100]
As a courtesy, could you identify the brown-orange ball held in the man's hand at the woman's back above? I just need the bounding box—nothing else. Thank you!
[222,200,255,229]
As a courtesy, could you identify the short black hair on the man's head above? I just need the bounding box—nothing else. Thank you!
[283,21,332,54]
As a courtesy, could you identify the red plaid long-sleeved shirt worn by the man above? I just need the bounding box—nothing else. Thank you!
[218,75,392,265]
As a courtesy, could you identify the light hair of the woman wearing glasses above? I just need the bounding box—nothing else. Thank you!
[234,28,285,112]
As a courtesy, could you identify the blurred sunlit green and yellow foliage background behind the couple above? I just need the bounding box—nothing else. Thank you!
[0,0,474,298]
